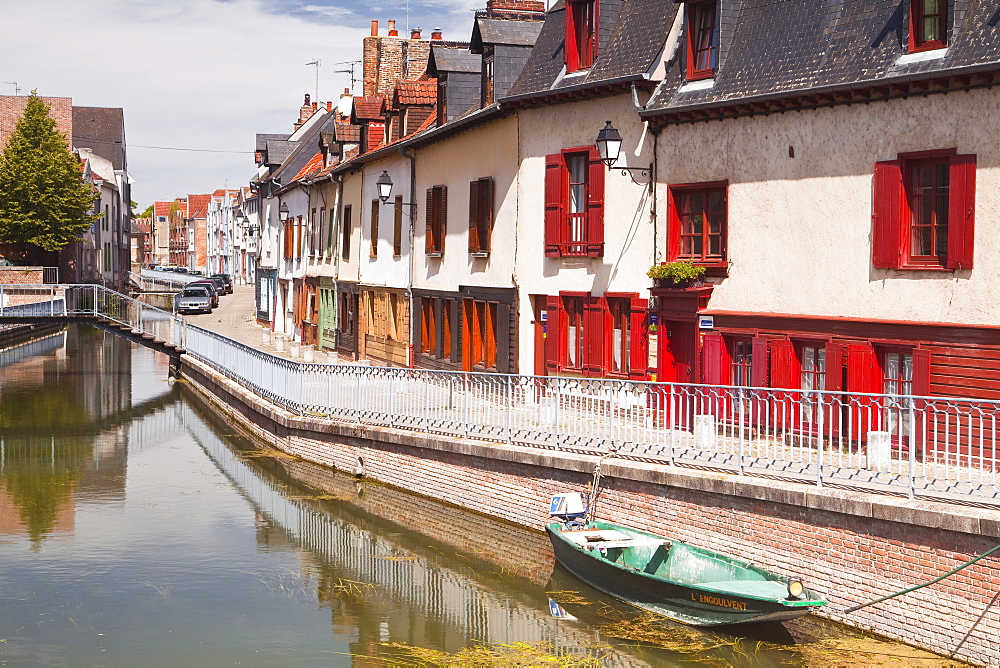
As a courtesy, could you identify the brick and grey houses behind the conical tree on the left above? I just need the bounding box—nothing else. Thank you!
[0,95,133,289]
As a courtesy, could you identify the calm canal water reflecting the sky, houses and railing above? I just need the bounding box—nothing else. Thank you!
[0,326,961,666]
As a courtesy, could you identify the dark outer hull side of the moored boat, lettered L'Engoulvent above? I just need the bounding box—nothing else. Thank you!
[547,525,823,626]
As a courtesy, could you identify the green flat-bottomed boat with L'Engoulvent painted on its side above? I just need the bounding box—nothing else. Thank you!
[546,521,826,626]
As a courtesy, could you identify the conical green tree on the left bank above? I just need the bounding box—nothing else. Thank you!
[0,91,100,251]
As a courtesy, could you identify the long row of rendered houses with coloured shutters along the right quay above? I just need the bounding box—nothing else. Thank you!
[244,0,1000,398]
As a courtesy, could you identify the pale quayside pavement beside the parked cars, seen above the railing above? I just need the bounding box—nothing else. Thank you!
[184,285,337,364]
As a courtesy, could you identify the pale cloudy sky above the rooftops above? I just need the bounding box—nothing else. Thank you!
[0,0,485,211]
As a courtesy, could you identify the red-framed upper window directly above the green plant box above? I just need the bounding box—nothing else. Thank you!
[667,181,728,269]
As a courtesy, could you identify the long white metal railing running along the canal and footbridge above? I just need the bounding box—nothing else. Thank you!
[0,286,1000,503]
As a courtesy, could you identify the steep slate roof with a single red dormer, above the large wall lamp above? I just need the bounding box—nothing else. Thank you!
[506,0,668,100]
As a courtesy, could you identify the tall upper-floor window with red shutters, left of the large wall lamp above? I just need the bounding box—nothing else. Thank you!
[545,147,605,257]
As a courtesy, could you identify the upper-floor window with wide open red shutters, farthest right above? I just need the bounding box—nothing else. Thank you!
[872,150,976,269]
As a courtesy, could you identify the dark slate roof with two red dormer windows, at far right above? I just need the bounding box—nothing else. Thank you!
[643,0,1000,116]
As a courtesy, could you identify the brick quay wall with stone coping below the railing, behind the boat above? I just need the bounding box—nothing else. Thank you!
[182,356,1000,666]
